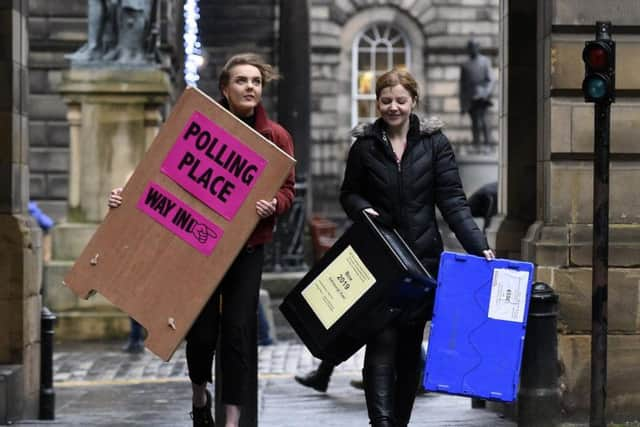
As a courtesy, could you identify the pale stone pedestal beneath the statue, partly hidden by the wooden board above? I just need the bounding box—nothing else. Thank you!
[44,68,172,339]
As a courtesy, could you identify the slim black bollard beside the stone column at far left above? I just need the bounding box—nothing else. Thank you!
[38,307,56,420]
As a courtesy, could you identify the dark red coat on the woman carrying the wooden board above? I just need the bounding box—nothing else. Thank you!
[247,104,295,246]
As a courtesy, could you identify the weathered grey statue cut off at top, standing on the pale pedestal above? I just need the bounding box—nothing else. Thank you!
[69,0,157,66]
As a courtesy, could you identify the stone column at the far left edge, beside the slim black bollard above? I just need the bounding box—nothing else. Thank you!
[0,0,42,425]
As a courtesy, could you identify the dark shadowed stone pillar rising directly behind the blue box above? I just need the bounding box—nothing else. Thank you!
[487,0,538,259]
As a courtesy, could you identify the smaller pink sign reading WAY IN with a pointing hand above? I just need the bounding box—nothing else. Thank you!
[137,182,223,256]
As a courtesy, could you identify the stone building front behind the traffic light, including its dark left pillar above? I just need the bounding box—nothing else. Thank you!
[494,0,640,422]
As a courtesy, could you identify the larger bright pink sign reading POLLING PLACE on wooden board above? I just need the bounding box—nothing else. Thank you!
[161,111,267,220]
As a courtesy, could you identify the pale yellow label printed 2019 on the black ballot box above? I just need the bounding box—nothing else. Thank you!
[302,246,376,329]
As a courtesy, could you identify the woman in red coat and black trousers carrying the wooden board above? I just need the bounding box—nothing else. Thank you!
[109,53,295,427]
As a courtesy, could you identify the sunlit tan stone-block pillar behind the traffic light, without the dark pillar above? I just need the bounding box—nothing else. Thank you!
[510,0,640,422]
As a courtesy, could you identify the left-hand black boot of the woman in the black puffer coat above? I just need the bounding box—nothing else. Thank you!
[362,365,396,427]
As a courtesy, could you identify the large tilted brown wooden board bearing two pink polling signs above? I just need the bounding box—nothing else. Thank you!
[64,88,295,360]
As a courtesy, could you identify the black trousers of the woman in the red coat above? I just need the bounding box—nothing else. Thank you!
[187,245,264,405]
